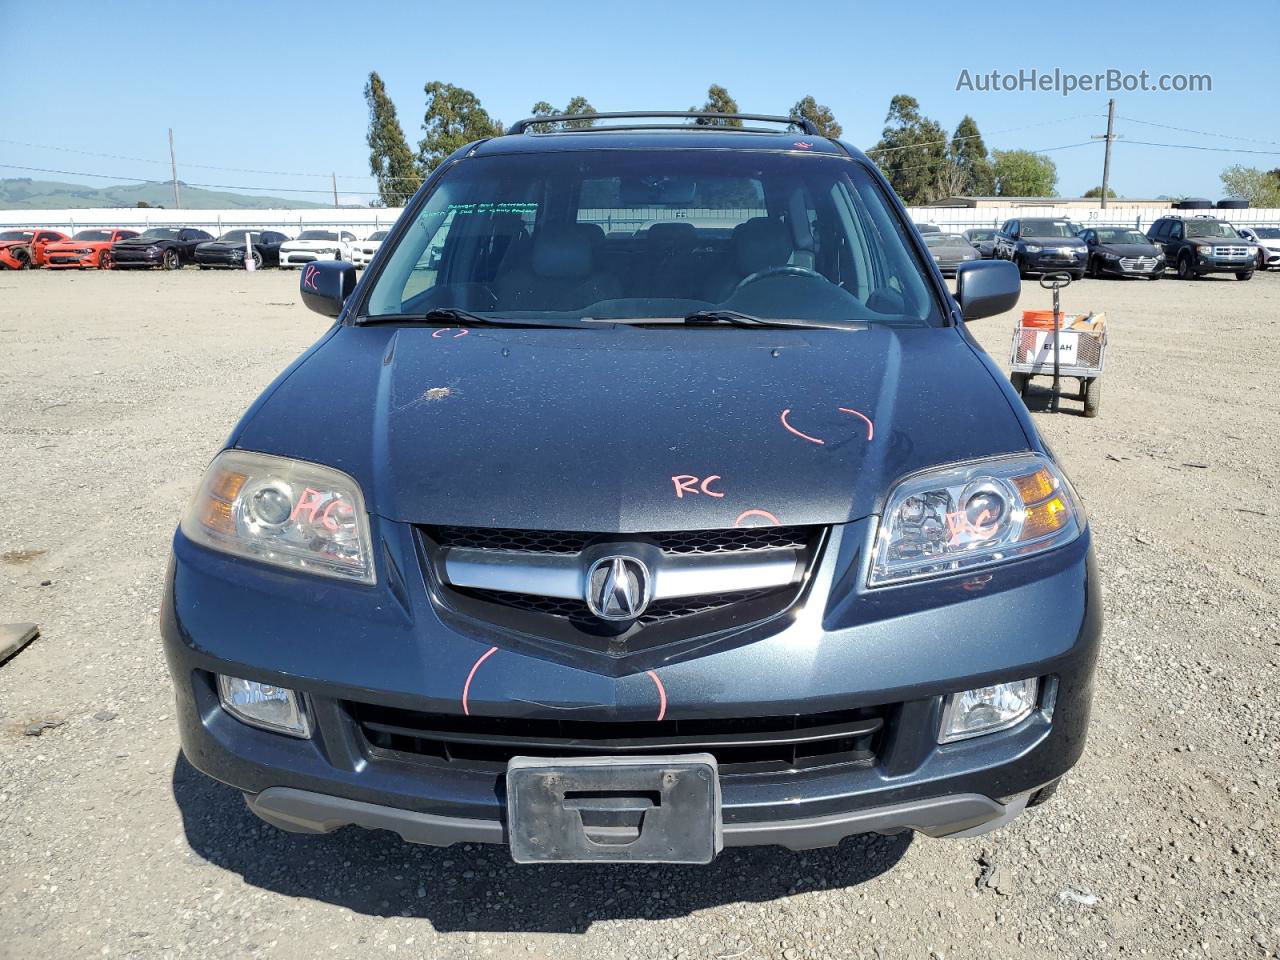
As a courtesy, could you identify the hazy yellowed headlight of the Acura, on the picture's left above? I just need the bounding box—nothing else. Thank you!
[182,451,375,584]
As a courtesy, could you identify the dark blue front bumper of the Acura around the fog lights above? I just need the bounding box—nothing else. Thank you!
[161,517,1101,849]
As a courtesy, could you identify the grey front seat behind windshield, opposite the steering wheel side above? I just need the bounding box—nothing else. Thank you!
[494,224,618,310]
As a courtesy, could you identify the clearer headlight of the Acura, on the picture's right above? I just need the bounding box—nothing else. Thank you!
[868,454,1084,586]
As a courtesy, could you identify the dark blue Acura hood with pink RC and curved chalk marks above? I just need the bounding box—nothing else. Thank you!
[234,326,1029,532]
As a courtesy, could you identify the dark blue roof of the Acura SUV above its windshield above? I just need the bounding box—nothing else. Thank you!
[468,127,860,156]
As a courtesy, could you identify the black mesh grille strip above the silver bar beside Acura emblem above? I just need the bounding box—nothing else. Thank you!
[428,526,813,554]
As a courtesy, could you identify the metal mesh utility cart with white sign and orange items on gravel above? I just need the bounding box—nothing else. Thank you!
[1009,274,1107,417]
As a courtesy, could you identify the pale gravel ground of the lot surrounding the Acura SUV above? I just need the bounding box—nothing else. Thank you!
[0,271,1280,960]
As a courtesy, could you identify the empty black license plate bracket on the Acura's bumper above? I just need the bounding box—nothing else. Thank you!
[507,754,723,864]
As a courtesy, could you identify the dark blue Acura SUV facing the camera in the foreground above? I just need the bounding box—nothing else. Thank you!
[161,110,1102,861]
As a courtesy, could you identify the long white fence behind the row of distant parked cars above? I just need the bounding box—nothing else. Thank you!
[0,206,1280,239]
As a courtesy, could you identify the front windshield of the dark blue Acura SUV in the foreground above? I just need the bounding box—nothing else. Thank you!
[361,150,942,326]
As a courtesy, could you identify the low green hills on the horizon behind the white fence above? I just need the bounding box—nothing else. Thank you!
[0,177,332,210]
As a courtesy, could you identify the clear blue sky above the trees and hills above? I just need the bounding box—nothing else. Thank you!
[0,0,1280,200]
